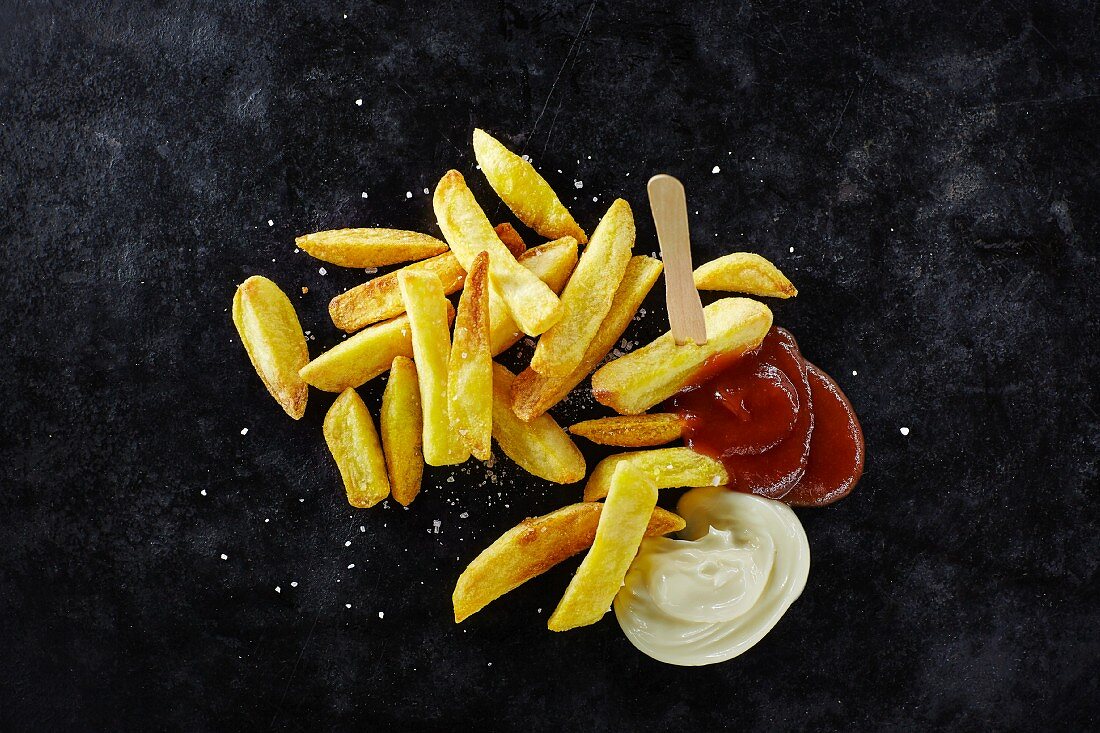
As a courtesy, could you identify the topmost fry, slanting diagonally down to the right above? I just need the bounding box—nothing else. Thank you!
[474,130,589,244]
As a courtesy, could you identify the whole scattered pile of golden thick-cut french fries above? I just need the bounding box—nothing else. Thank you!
[233,130,796,631]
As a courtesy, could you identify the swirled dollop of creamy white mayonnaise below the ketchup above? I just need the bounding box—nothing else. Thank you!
[615,486,810,666]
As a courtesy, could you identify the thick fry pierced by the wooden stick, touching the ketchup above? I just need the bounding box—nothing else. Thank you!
[592,298,771,415]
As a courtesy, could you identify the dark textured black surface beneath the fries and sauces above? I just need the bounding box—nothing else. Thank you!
[0,0,1100,731]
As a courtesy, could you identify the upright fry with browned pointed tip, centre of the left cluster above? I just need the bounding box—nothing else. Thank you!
[447,252,493,461]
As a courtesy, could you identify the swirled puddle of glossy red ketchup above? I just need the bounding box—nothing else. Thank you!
[664,327,864,506]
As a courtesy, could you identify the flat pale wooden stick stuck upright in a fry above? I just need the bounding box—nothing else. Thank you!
[648,173,706,343]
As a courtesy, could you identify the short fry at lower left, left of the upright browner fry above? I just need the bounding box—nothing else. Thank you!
[323,389,389,508]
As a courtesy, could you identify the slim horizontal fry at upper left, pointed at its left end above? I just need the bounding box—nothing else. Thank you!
[294,229,447,267]
